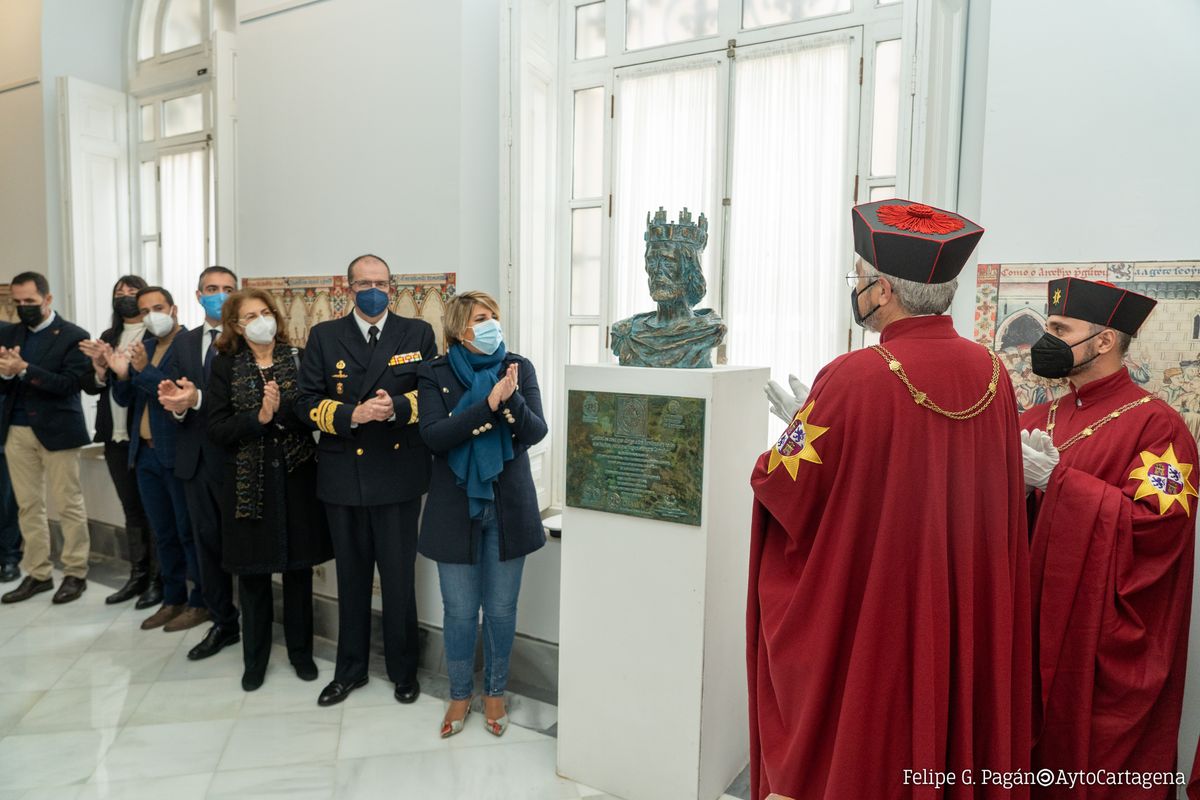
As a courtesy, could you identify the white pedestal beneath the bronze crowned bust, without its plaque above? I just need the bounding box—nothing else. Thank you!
[558,366,769,800]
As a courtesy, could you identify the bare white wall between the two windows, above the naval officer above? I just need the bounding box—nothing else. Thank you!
[236,0,499,291]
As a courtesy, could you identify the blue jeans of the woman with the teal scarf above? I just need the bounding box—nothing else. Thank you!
[438,506,524,700]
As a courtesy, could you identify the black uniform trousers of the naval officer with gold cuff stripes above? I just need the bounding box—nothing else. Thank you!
[325,498,421,684]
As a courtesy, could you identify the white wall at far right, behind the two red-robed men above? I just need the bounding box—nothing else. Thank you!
[954,0,1200,786]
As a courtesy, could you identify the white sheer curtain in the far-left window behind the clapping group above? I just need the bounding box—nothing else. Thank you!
[158,148,208,327]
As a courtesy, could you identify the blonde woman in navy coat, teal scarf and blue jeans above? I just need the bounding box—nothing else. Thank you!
[418,291,546,739]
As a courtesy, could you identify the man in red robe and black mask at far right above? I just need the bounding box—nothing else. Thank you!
[1021,278,1196,800]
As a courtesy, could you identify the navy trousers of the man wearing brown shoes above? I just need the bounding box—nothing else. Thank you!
[137,441,204,608]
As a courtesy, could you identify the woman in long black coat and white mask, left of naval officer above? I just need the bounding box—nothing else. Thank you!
[206,289,334,692]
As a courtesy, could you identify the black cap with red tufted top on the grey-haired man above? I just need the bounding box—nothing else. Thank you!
[850,198,983,283]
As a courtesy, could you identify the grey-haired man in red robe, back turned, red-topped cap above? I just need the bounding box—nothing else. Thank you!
[748,200,1032,800]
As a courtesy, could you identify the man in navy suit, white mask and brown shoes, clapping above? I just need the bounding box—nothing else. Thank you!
[108,287,209,632]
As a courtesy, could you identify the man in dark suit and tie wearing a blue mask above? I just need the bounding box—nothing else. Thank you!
[158,266,240,661]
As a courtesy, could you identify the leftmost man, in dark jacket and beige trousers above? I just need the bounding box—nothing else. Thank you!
[0,272,91,603]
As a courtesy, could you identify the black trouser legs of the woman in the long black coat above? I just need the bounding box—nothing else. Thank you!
[238,567,312,678]
